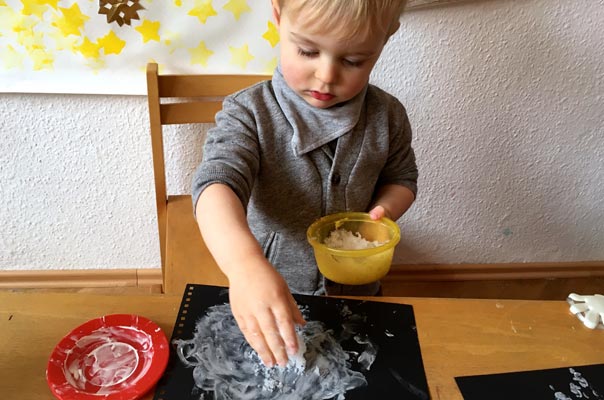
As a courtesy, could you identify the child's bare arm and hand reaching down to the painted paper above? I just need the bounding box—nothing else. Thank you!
[195,184,305,366]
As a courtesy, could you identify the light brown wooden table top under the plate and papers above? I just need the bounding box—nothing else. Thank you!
[0,292,604,400]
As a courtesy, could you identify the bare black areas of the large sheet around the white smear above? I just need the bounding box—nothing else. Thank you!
[154,284,430,400]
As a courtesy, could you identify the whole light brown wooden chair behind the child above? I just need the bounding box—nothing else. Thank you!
[147,63,270,294]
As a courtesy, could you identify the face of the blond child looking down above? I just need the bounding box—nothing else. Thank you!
[273,1,391,108]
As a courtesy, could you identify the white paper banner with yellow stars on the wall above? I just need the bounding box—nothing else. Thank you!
[0,0,279,94]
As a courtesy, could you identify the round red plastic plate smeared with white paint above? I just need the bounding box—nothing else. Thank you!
[46,314,170,400]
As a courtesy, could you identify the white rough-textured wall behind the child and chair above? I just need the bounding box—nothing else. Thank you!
[0,0,604,269]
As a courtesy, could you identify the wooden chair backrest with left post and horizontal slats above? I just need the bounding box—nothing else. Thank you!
[147,63,271,273]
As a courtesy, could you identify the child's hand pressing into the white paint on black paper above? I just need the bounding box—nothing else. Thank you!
[229,261,306,367]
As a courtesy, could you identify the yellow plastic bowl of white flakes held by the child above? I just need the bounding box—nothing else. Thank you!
[306,212,401,285]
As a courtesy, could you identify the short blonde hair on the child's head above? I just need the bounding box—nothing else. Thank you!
[278,0,407,38]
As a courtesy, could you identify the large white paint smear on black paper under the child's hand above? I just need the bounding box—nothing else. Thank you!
[174,304,377,400]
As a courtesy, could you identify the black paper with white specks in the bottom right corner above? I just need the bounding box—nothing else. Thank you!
[455,364,604,400]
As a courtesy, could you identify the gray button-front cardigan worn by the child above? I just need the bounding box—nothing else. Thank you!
[192,71,418,294]
